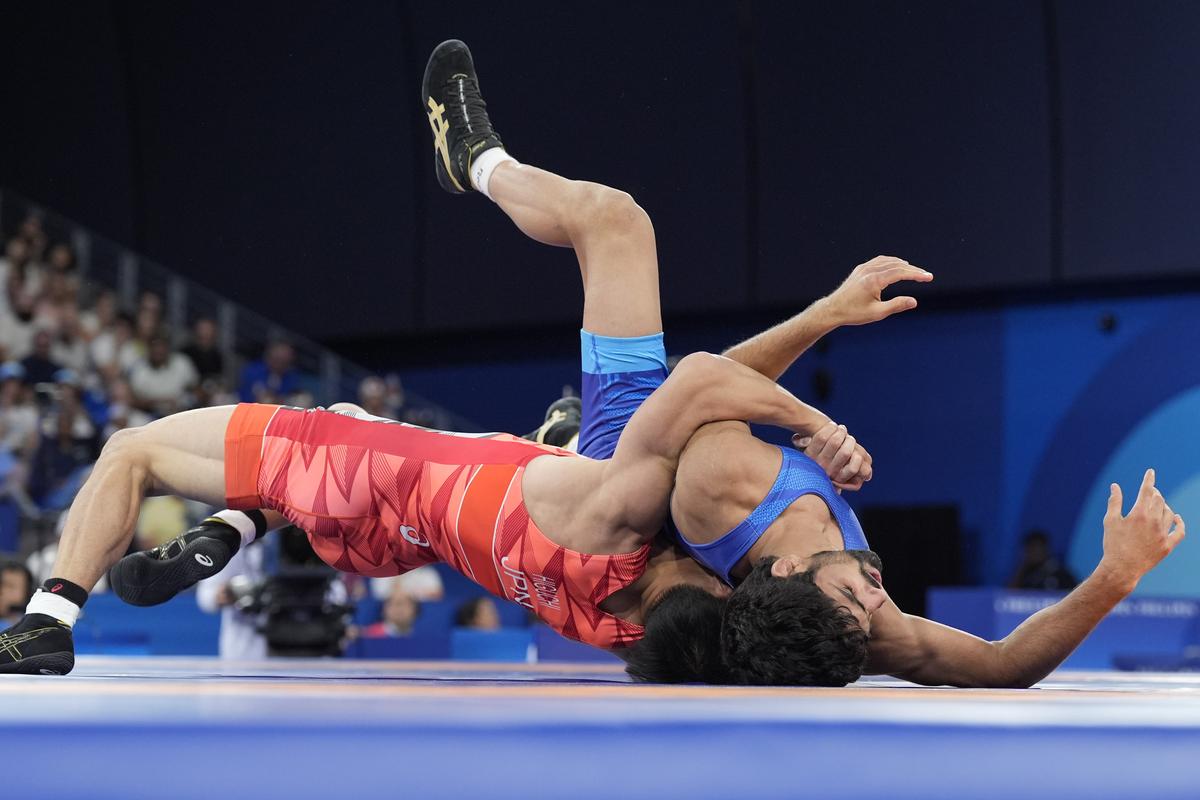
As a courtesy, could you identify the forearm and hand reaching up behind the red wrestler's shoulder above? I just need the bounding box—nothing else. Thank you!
[724,255,934,380]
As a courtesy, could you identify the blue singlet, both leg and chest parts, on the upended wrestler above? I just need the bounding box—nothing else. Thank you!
[578,331,868,585]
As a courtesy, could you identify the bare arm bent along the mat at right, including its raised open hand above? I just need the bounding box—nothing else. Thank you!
[866,470,1186,687]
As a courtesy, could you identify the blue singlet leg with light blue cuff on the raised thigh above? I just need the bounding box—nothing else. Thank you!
[578,331,667,458]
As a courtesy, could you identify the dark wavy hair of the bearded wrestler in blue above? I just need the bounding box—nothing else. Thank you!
[721,558,866,686]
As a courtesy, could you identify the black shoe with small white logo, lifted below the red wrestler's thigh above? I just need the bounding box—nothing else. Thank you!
[108,517,241,606]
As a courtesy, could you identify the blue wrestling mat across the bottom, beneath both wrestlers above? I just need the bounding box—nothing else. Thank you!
[0,657,1200,800]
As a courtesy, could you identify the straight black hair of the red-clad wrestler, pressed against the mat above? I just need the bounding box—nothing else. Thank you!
[622,584,728,684]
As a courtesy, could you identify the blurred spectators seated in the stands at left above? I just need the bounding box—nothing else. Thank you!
[0,215,430,581]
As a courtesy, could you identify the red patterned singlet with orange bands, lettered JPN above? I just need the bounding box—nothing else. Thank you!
[226,404,649,649]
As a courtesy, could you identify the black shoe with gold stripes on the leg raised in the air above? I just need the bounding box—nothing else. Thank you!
[421,38,504,194]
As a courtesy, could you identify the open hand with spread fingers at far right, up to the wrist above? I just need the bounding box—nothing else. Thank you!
[1097,469,1186,589]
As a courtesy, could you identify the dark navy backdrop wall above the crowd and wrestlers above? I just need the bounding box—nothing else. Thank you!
[7,0,1200,345]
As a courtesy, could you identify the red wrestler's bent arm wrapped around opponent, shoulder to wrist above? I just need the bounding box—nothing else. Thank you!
[600,353,829,540]
